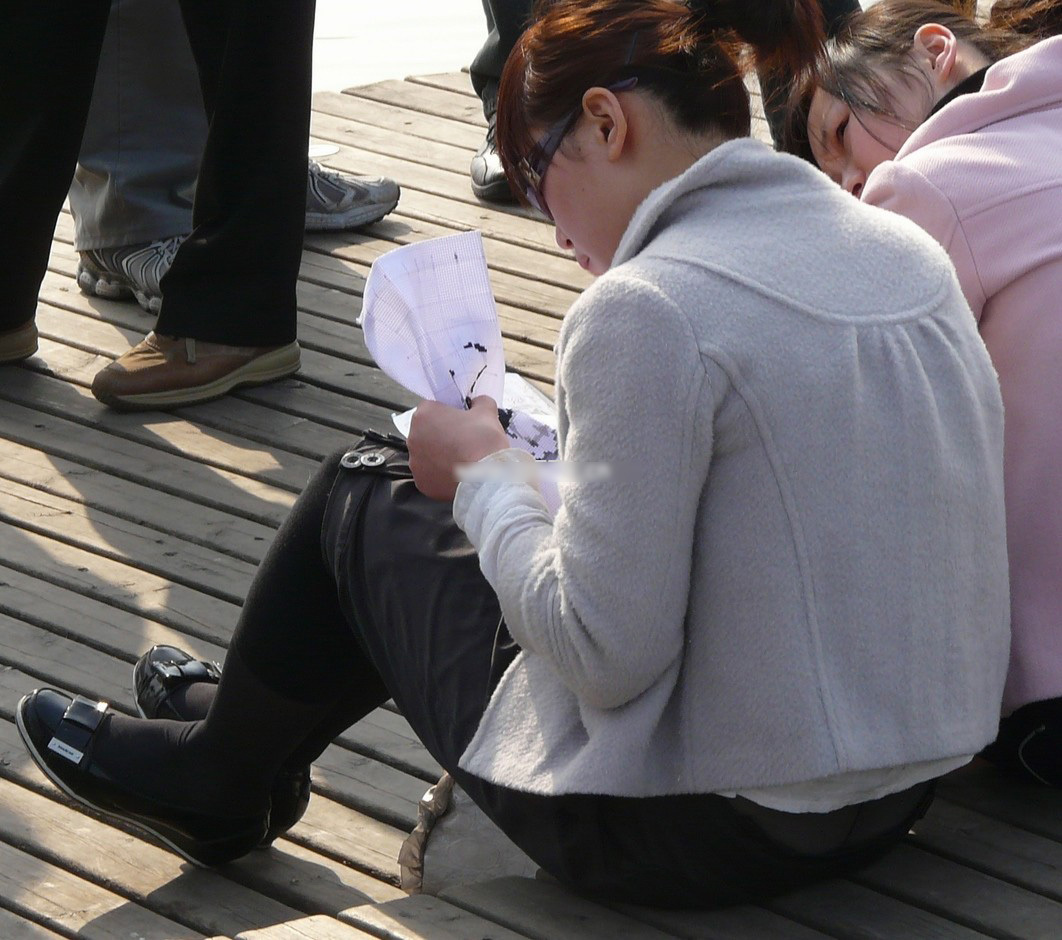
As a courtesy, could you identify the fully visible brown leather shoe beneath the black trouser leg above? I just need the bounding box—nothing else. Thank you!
[92,331,299,411]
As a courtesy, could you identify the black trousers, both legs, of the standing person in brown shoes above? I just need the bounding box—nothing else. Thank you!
[0,0,314,345]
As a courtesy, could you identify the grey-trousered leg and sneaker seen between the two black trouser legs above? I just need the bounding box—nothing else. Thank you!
[70,0,207,313]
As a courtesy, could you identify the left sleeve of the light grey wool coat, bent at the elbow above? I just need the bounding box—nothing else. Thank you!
[455,272,712,708]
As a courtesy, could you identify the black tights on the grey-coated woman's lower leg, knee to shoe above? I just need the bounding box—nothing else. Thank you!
[95,450,389,816]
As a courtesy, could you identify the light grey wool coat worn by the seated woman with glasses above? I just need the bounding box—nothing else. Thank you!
[453,139,1009,797]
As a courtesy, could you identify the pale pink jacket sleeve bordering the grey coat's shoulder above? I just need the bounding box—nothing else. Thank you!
[861,160,987,321]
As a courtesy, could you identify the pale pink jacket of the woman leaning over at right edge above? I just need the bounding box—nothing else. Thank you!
[862,36,1062,714]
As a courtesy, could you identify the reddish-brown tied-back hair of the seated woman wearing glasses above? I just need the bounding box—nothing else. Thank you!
[497,0,822,207]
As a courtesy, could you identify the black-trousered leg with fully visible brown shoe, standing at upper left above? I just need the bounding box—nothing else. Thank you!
[92,0,314,408]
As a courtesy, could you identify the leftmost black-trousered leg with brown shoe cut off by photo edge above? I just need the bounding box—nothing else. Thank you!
[0,0,110,363]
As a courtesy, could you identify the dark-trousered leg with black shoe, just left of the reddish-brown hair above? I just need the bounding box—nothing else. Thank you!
[468,0,533,202]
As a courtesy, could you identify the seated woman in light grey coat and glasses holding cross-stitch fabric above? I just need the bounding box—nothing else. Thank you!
[18,0,1009,907]
